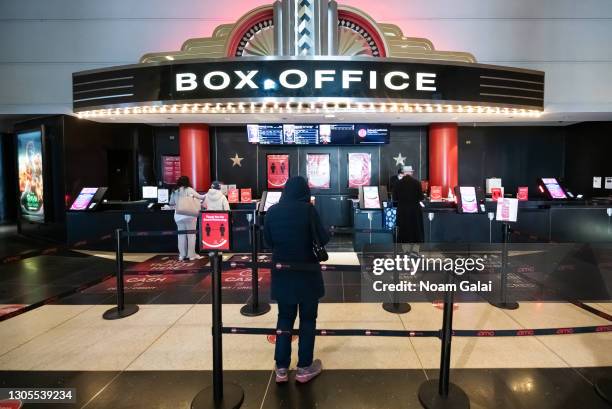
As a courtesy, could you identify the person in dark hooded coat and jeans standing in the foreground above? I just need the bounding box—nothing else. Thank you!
[264,176,329,383]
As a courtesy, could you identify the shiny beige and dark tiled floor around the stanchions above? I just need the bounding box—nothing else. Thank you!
[0,249,612,409]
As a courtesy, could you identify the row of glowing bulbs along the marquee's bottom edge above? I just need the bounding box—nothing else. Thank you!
[77,102,542,118]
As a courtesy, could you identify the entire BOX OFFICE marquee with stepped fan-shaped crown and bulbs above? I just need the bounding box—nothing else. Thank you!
[73,0,544,117]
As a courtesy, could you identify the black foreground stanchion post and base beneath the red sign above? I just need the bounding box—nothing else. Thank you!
[191,251,244,409]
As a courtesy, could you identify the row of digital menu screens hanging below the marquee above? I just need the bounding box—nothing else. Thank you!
[247,124,389,145]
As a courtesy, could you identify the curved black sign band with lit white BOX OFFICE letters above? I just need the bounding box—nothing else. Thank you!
[73,57,544,112]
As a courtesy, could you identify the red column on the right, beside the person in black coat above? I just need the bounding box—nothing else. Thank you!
[429,123,459,197]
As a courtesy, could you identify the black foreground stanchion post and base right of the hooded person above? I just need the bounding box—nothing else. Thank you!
[419,291,470,409]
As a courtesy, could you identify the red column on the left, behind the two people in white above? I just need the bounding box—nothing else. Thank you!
[179,124,211,192]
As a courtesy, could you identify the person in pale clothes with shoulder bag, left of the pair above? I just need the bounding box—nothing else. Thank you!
[170,176,204,261]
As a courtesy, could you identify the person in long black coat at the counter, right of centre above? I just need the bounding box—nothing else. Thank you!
[393,166,425,243]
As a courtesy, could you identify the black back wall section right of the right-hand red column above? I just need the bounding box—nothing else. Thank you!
[458,126,568,197]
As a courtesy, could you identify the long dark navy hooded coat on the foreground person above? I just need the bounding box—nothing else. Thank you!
[264,176,329,304]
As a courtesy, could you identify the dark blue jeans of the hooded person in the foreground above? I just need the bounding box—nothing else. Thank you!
[274,300,319,368]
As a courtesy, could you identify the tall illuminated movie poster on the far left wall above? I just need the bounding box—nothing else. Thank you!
[17,130,45,222]
